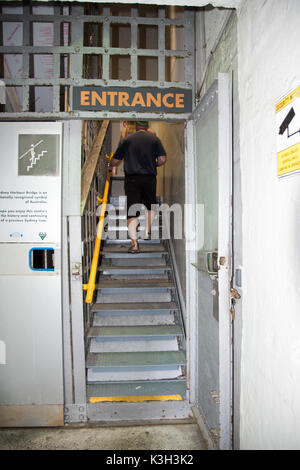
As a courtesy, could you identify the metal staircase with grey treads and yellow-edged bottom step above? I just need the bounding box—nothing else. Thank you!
[86,180,186,403]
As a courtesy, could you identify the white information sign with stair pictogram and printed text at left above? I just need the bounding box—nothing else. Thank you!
[0,123,62,244]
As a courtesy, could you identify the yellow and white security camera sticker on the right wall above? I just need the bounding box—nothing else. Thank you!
[276,86,300,177]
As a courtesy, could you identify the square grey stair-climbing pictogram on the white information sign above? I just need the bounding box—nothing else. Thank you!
[18,134,59,176]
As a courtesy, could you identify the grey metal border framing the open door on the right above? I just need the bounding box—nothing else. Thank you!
[186,73,233,449]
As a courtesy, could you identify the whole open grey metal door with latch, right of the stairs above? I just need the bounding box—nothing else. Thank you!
[193,74,232,449]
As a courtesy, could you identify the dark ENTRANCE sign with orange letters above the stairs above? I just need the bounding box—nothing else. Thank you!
[73,87,192,113]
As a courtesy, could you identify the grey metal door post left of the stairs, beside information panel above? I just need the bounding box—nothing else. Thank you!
[62,120,87,424]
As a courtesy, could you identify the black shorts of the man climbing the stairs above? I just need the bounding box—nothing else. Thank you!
[124,175,156,218]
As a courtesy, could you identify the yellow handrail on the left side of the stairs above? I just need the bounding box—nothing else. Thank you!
[82,153,113,304]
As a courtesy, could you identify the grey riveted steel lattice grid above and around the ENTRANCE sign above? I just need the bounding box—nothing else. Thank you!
[0,2,194,120]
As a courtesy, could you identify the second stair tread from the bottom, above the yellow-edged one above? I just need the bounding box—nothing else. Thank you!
[86,351,186,368]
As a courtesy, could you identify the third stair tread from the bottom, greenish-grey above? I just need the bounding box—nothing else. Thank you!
[88,325,183,338]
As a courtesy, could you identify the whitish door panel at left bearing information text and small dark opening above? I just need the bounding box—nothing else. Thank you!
[0,122,63,426]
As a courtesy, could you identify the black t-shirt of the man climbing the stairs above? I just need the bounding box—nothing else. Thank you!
[113,131,166,175]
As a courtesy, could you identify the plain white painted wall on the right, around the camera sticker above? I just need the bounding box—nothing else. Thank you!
[238,0,300,449]
